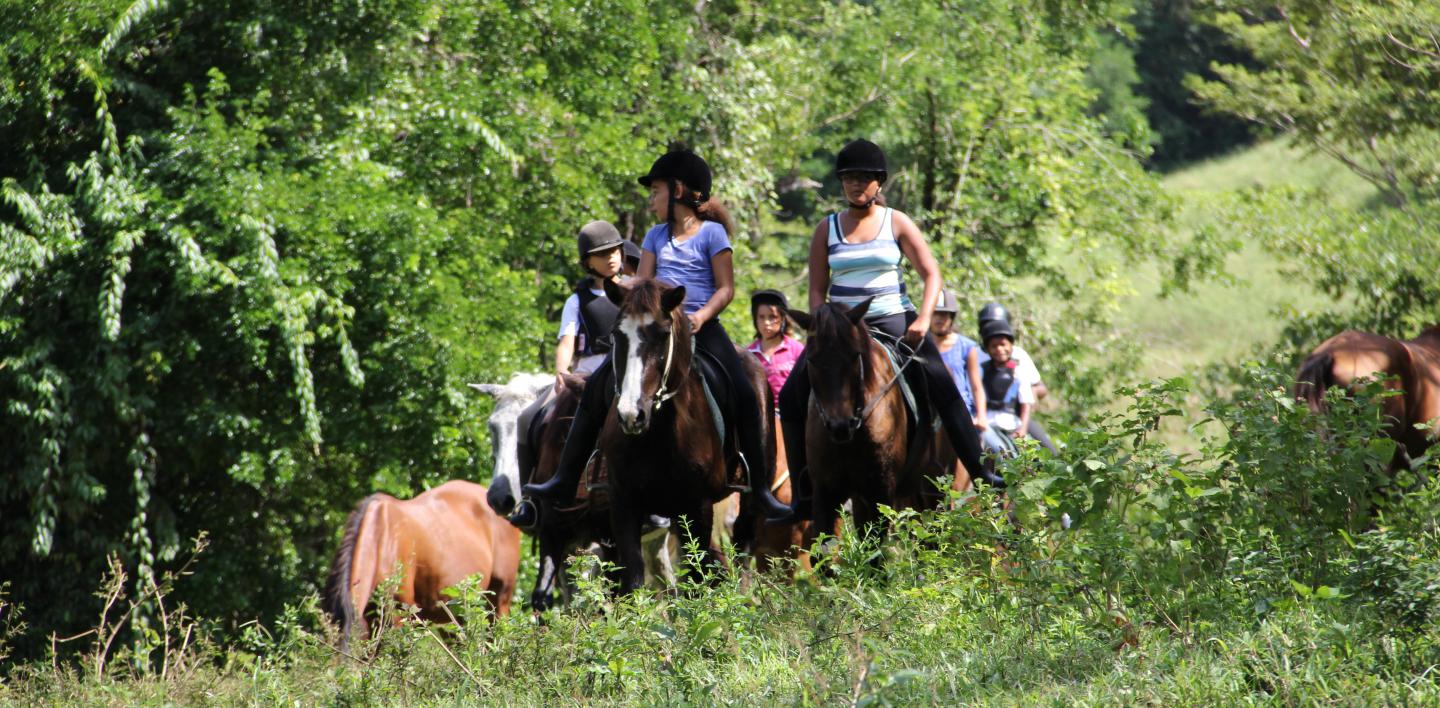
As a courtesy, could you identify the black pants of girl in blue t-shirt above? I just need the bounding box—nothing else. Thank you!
[564,319,771,481]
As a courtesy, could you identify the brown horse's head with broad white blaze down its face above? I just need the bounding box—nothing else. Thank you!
[605,281,691,435]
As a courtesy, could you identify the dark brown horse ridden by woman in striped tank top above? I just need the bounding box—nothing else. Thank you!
[792,301,968,545]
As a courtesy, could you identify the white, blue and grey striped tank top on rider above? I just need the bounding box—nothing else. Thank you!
[827,207,914,319]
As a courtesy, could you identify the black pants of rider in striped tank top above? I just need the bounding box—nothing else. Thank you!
[779,312,981,478]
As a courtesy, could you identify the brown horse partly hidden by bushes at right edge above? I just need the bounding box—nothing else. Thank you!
[1295,325,1440,471]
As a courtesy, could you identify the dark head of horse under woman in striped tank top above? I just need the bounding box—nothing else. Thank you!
[791,299,871,442]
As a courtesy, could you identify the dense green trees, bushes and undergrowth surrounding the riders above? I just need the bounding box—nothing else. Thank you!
[0,0,1440,702]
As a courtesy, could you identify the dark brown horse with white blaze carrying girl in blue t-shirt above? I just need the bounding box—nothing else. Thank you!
[600,279,768,593]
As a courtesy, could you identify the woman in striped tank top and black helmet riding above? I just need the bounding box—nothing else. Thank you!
[772,140,1005,521]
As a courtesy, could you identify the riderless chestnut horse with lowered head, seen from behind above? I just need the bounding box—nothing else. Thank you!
[324,479,520,650]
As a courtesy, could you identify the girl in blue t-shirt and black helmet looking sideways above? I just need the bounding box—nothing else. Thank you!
[524,150,789,517]
